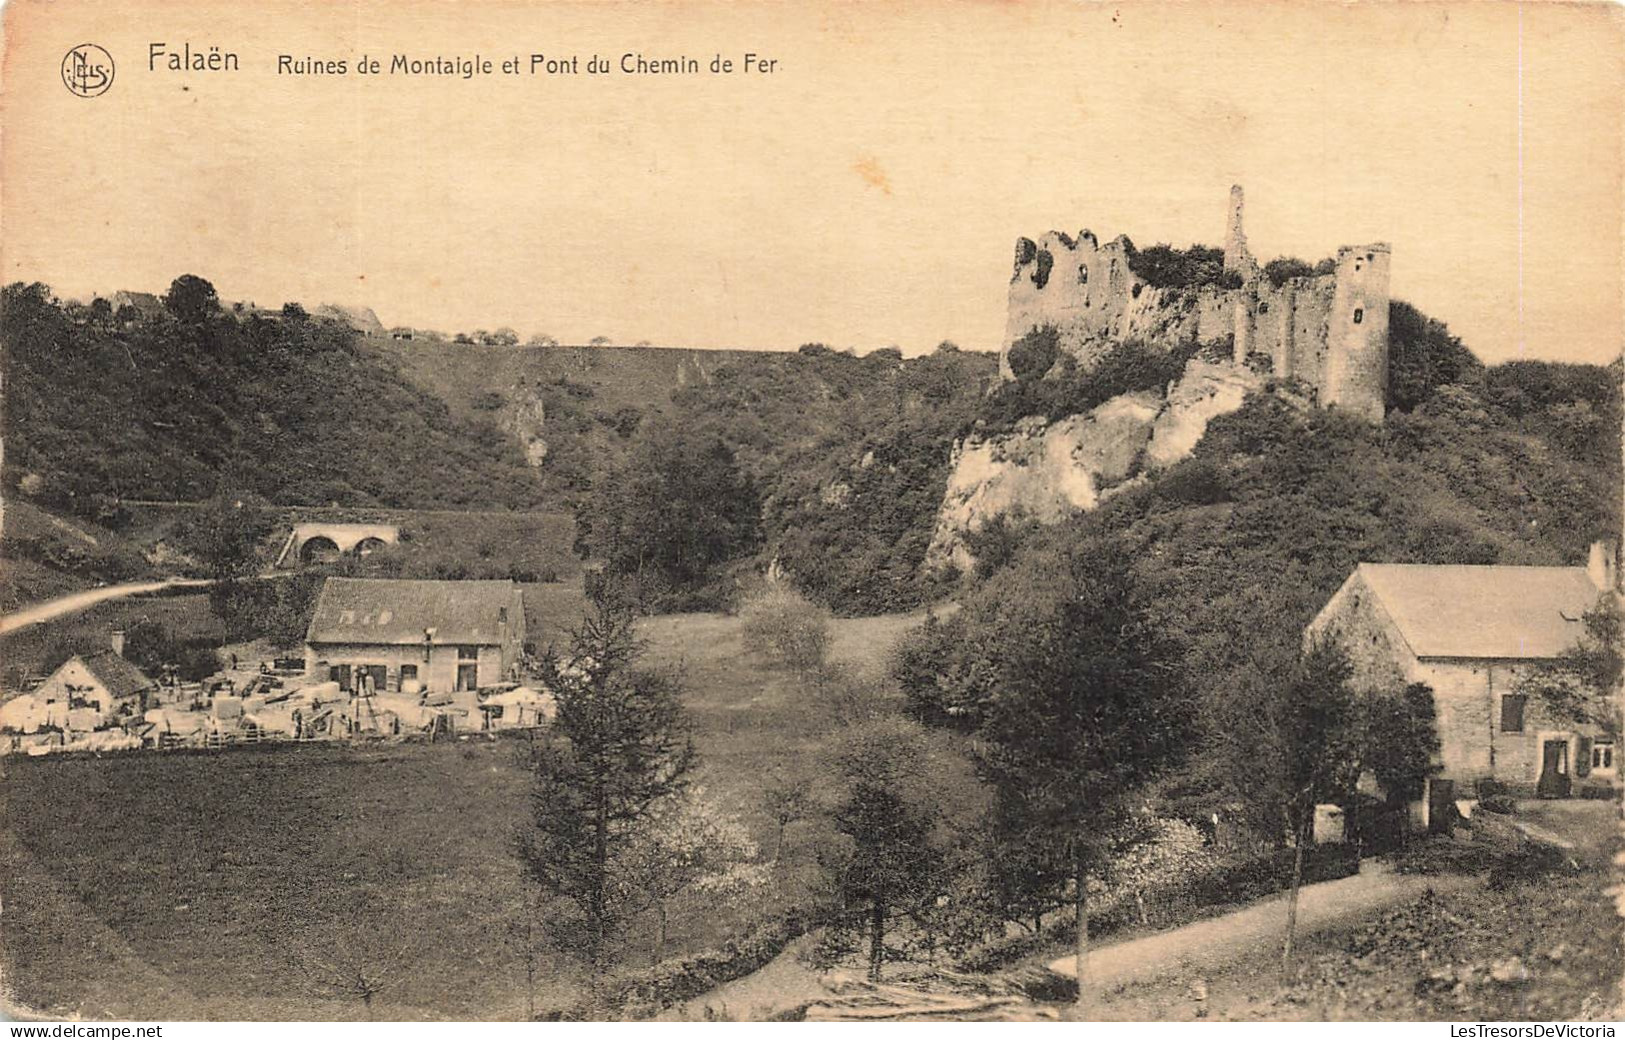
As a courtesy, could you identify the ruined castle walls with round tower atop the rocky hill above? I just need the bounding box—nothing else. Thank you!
[999,185,1389,421]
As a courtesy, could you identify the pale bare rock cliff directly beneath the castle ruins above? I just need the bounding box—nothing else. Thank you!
[926,358,1264,569]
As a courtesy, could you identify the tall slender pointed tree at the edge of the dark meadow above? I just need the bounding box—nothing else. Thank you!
[517,583,694,977]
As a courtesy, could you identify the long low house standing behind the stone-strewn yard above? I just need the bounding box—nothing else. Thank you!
[306,579,525,692]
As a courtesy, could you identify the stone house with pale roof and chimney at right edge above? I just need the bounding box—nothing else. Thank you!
[1307,544,1619,804]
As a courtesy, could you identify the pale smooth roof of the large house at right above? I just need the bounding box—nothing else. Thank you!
[1359,564,1602,660]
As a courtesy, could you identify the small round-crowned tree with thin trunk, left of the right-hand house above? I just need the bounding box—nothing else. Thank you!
[1216,639,1363,975]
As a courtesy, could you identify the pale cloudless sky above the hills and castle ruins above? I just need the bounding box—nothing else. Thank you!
[0,0,1625,362]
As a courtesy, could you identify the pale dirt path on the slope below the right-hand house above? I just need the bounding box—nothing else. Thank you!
[1048,860,1484,990]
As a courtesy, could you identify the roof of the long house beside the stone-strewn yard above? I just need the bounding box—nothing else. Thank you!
[306,579,525,647]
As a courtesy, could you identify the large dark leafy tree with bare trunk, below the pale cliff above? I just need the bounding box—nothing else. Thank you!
[977,540,1191,1003]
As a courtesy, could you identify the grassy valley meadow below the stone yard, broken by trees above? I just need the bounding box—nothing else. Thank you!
[0,601,973,1019]
